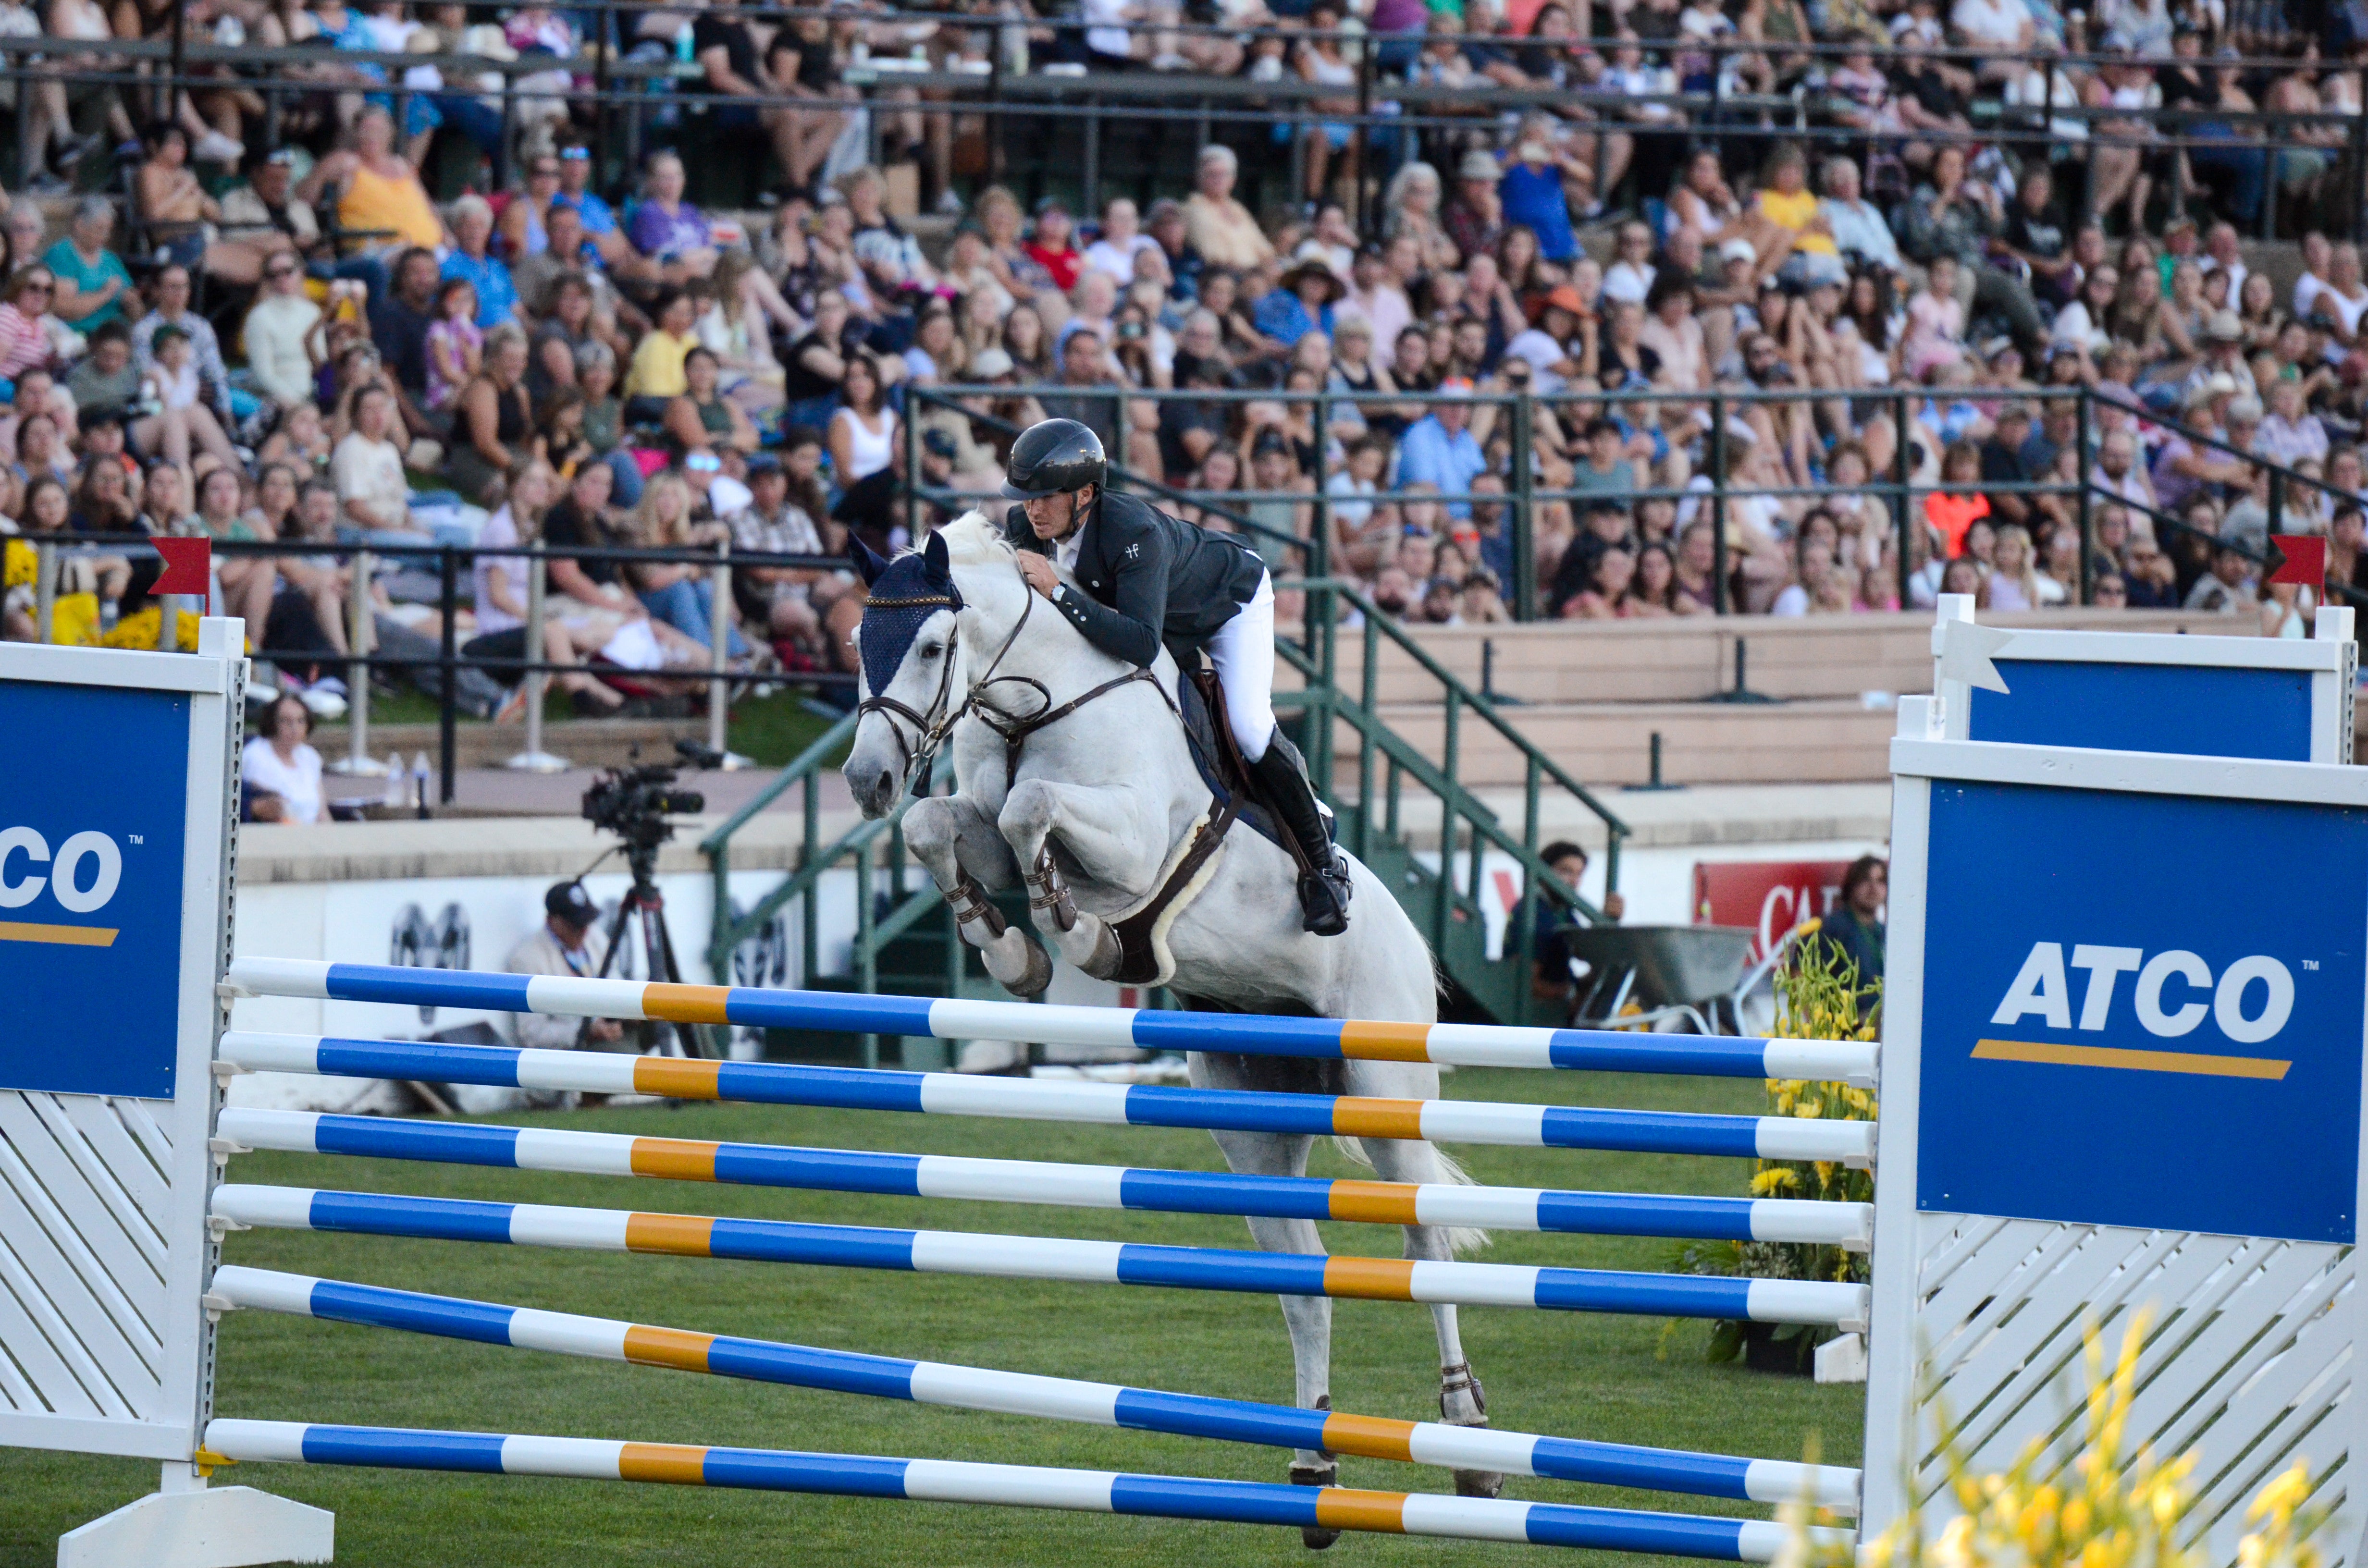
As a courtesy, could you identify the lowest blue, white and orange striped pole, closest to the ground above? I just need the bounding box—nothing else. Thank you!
[206,1421,1857,1563]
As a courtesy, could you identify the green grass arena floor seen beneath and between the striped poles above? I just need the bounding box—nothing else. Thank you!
[0,1071,1863,1568]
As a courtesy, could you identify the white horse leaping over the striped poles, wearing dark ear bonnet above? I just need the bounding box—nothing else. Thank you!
[843,512,1504,1547]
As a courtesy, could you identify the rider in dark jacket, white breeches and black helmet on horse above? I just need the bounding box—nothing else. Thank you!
[1004,419,1350,936]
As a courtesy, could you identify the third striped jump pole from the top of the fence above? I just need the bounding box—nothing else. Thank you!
[220,1108,1875,1250]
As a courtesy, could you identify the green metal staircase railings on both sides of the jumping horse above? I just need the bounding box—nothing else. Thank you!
[699,578,1629,1066]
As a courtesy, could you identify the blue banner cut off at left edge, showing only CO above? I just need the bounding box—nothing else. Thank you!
[0,682,189,1099]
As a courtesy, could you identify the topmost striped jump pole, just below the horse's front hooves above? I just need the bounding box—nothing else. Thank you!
[225,959,1878,1090]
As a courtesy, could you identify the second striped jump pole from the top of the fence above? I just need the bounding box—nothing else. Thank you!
[218,1037,1875,1165]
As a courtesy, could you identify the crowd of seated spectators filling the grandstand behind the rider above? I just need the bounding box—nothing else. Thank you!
[0,0,2368,725]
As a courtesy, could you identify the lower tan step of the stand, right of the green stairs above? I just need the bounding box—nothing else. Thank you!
[1364,699,1899,798]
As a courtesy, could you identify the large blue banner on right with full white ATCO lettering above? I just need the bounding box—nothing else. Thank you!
[1916,782,2368,1241]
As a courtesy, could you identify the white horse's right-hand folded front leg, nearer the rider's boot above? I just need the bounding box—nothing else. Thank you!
[997,779,1168,980]
